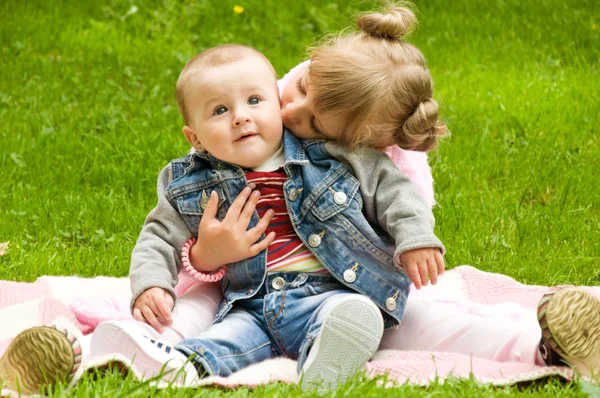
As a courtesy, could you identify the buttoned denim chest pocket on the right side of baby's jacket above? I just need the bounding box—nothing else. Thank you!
[310,171,362,221]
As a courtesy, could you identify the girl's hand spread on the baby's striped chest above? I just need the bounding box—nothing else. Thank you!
[190,187,275,272]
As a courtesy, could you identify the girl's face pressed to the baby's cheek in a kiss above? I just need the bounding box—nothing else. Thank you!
[281,67,344,140]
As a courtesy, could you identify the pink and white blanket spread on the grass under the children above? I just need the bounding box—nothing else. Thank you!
[0,266,600,395]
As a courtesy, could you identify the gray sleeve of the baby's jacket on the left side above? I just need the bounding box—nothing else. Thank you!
[129,165,193,310]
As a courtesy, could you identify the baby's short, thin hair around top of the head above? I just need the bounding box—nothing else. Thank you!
[175,44,277,124]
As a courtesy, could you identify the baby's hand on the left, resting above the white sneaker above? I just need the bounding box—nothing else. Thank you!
[133,287,174,333]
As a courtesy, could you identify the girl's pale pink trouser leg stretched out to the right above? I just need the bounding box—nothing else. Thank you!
[379,296,544,365]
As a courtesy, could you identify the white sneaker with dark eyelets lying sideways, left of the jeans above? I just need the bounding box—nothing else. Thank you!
[90,321,200,387]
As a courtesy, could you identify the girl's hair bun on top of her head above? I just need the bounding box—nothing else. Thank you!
[356,3,418,40]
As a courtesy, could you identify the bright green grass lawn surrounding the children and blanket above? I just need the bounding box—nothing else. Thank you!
[0,0,600,397]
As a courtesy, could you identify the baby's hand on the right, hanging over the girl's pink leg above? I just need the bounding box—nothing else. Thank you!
[400,247,444,289]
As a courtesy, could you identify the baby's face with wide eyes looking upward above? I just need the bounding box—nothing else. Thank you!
[183,57,283,168]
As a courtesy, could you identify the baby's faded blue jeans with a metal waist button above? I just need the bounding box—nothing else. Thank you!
[175,272,358,376]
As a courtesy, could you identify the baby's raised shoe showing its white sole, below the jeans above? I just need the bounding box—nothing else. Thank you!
[300,294,383,394]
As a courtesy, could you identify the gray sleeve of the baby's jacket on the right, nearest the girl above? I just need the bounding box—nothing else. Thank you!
[325,141,445,265]
